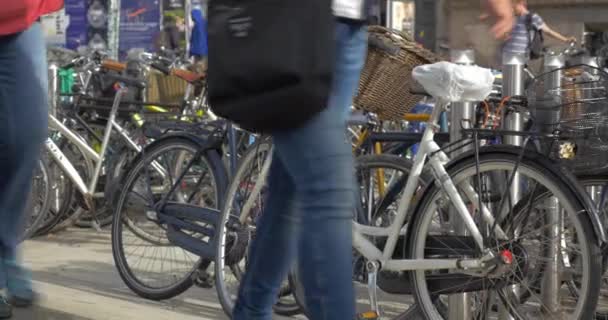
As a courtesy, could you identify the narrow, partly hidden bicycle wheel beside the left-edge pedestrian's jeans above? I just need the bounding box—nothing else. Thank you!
[21,159,51,240]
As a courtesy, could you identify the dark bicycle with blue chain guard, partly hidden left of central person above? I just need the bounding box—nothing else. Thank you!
[111,118,228,300]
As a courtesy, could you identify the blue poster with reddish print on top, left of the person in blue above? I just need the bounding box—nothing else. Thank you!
[118,0,161,58]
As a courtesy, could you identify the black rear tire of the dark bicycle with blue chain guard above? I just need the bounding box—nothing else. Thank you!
[111,136,227,301]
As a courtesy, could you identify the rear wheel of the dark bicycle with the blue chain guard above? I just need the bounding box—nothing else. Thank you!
[112,137,227,300]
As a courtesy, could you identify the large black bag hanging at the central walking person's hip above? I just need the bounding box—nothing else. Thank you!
[207,0,336,133]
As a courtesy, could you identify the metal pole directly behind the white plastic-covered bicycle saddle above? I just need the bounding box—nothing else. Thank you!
[448,50,475,320]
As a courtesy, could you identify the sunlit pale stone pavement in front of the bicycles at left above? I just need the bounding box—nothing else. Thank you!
[13,229,296,320]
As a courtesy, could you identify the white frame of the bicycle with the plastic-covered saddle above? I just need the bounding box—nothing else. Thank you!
[240,102,507,271]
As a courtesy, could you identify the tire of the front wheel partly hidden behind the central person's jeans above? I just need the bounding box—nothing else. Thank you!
[215,138,301,317]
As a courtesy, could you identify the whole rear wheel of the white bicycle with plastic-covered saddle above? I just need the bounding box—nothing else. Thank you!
[408,148,601,320]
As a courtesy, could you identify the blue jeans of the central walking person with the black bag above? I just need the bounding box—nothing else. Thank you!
[233,24,367,320]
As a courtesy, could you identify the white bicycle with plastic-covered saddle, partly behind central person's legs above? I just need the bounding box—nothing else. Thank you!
[216,63,605,320]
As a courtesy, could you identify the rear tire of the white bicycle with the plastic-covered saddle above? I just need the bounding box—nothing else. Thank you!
[407,149,601,320]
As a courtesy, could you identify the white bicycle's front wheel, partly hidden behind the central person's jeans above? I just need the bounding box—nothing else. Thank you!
[215,139,301,317]
